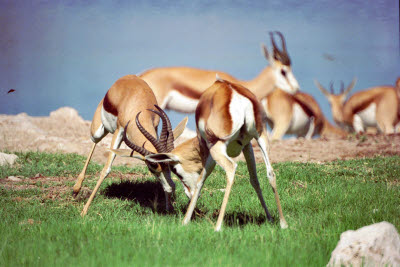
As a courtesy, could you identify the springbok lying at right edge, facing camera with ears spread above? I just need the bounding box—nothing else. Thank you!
[315,78,399,134]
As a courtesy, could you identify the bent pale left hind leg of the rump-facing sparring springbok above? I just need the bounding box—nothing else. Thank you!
[210,141,237,232]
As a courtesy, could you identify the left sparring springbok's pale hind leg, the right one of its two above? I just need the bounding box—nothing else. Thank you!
[81,128,122,217]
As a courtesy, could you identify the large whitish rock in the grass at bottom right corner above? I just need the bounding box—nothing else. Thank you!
[328,222,400,266]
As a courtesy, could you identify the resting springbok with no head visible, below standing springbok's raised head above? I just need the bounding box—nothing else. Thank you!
[261,89,347,140]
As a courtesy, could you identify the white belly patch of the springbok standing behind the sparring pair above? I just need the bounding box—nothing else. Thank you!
[162,91,199,113]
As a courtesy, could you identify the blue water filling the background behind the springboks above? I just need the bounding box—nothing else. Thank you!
[0,0,400,132]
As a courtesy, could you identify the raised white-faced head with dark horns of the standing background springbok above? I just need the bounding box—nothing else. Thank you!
[261,31,299,94]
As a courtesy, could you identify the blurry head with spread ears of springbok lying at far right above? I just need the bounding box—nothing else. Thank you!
[314,78,357,124]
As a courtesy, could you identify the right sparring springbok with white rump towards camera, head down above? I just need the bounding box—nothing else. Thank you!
[113,77,287,231]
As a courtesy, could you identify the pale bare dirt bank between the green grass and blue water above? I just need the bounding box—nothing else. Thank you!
[0,107,400,166]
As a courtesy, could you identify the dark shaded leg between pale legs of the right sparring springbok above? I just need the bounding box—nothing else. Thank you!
[243,143,272,221]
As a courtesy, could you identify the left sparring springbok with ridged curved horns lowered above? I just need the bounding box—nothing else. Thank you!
[73,75,187,217]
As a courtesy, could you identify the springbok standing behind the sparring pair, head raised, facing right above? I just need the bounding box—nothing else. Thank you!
[140,32,299,113]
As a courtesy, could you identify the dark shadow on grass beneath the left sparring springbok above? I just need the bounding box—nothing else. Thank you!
[104,181,167,213]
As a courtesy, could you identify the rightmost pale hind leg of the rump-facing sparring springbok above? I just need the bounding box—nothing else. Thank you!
[257,129,288,228]
